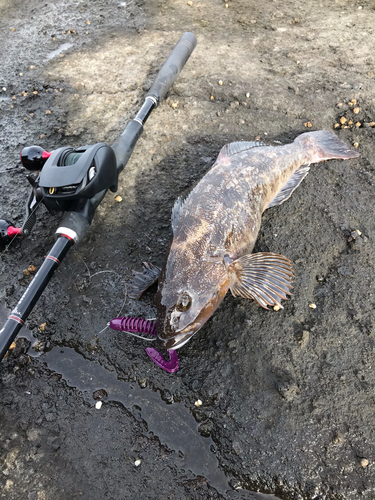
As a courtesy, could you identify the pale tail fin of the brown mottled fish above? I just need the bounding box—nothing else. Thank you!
[294,130,359,163]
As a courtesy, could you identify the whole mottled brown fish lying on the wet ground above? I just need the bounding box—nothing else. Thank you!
[130,130,359,350]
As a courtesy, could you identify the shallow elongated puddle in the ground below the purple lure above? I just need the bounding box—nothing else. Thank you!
[0,304,276,499]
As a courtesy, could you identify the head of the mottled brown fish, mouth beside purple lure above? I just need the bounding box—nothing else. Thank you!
[157,263,229,350]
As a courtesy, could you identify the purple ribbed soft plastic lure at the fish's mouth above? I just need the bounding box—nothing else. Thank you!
[109,316,178,373]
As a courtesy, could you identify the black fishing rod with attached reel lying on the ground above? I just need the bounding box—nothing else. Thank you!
[0,32,197,361]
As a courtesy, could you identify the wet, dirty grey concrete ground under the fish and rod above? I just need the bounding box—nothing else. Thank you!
[0,0,375,500]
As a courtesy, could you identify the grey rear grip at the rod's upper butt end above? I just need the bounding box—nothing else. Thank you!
[146,31,197,104]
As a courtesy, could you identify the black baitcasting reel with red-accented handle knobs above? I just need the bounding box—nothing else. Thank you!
[0,142,118,244]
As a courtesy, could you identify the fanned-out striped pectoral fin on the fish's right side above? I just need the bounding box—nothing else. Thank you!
[228,253,294,309]
